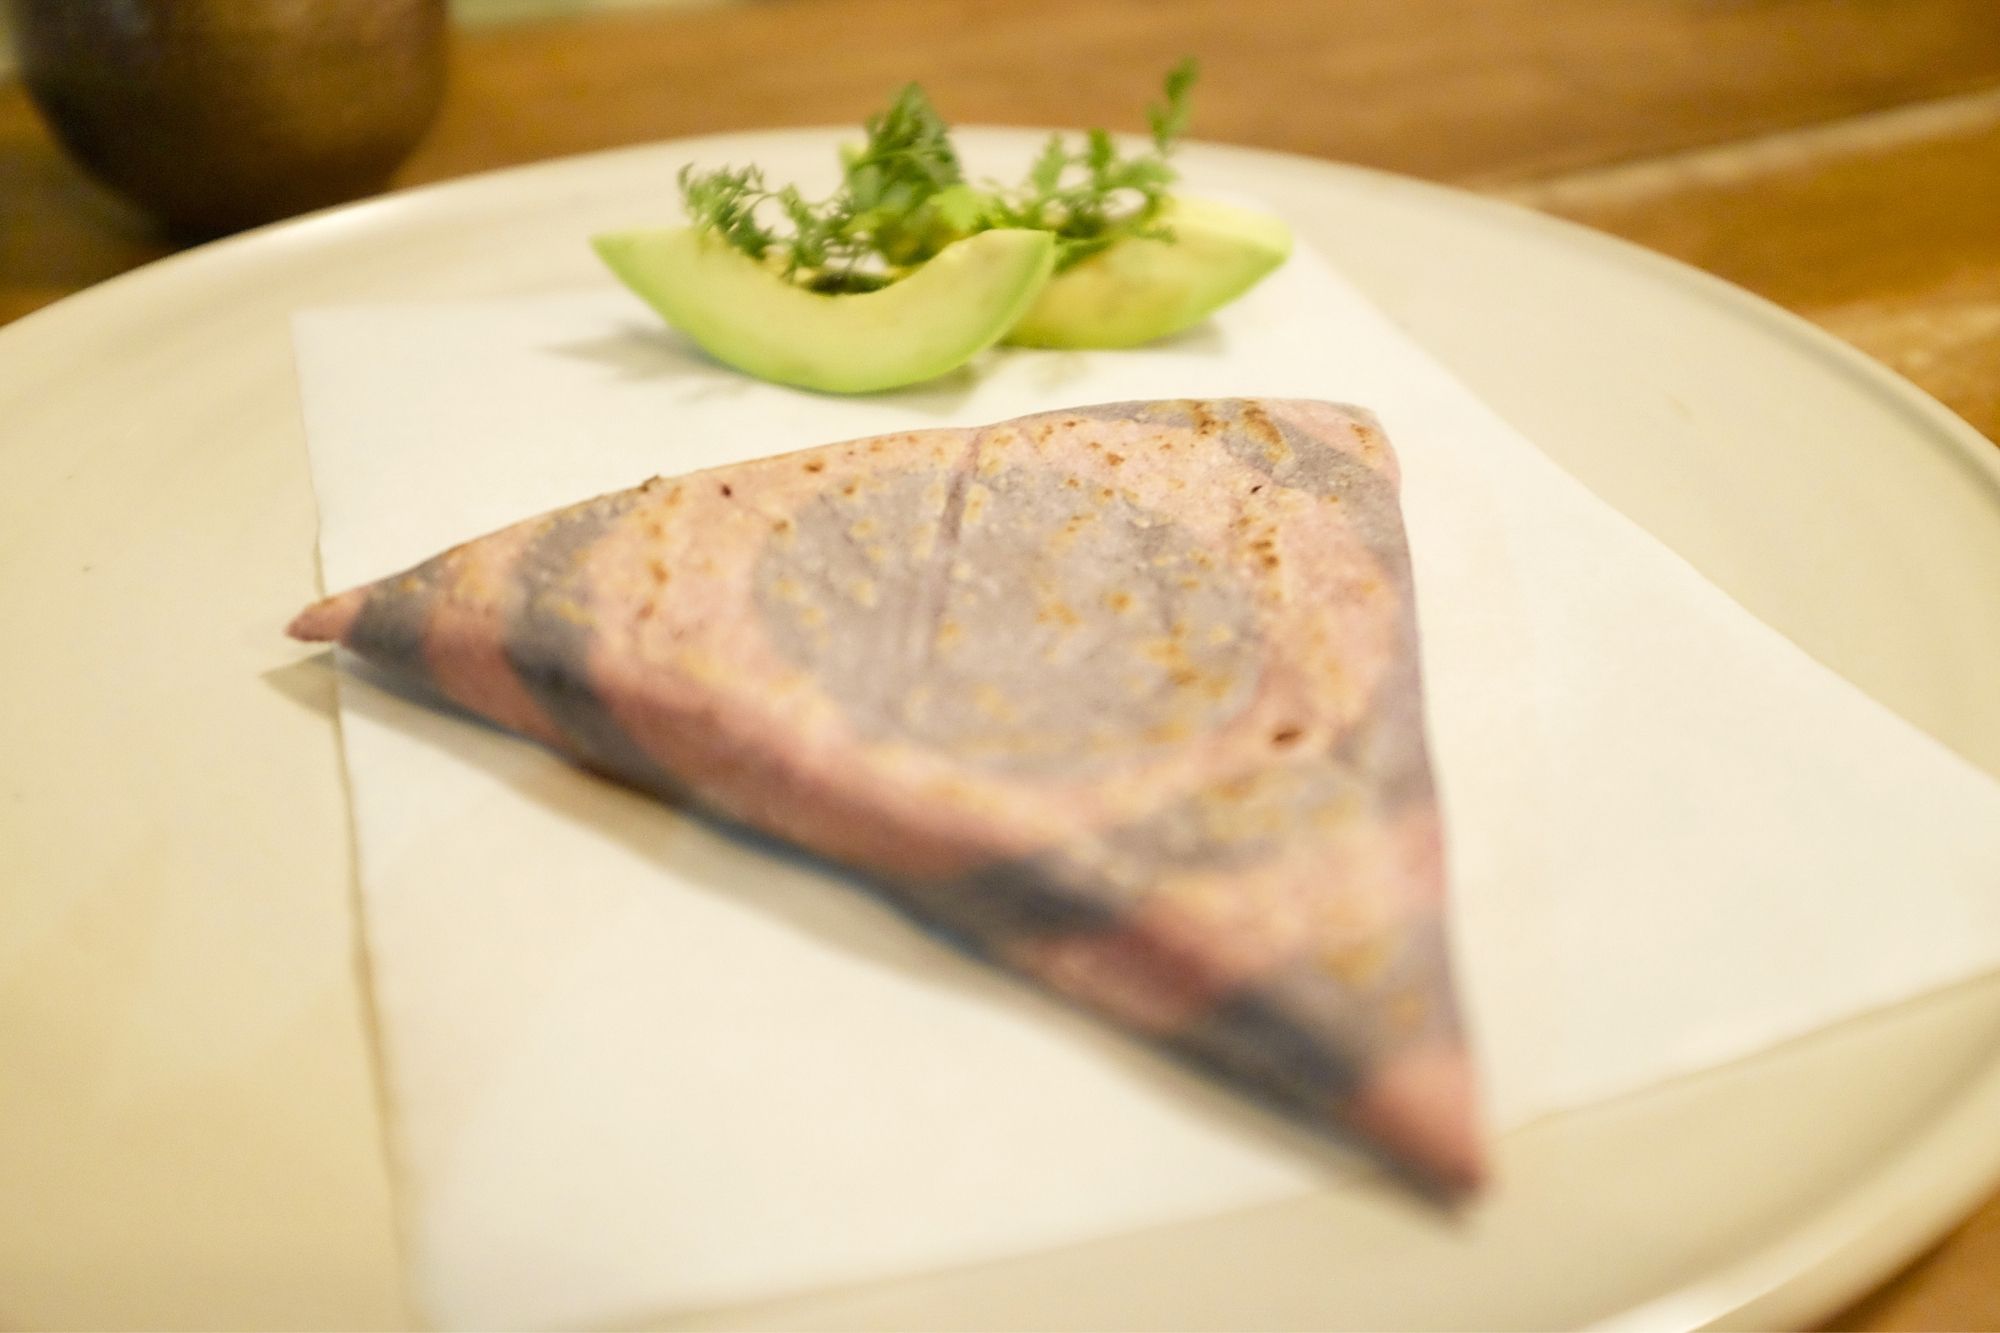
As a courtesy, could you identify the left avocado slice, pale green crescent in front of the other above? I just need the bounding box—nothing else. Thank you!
[592,226,1056,394]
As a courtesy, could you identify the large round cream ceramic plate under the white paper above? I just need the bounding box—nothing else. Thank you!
[0,130,2000,1329]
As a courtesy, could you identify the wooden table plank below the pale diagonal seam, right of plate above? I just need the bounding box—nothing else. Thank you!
[1500,89,2000,440]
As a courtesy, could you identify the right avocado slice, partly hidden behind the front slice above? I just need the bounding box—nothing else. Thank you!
[1006,198,1292,348]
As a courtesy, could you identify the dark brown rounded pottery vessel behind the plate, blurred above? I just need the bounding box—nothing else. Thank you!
[4,0,446,236]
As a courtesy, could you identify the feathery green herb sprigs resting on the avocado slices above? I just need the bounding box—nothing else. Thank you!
[680,58,1198,292]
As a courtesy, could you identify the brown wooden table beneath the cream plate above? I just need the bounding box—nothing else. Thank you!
[0,0,2000,1329]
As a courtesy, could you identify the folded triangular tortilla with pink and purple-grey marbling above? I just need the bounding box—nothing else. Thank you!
[292,400,1482,1195]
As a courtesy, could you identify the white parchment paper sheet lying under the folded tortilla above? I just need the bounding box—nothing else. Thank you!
[296,244,2000,1327]
